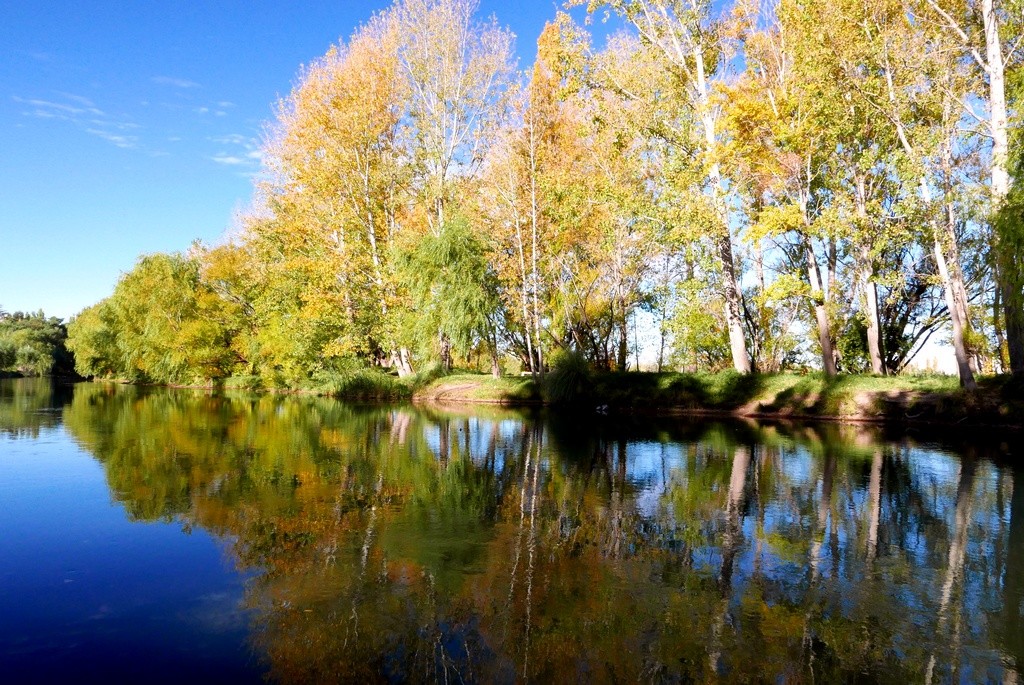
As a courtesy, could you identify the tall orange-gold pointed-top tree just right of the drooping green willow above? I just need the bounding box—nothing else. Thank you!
[483,14,658,373]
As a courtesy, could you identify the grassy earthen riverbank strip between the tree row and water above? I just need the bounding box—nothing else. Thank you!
[77,372,1024,429]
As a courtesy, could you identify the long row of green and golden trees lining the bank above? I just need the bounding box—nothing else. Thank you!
[64,0,1024,387]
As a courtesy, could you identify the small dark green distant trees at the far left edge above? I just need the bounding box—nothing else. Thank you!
[0,309,75,376]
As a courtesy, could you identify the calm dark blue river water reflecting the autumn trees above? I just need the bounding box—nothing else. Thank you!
[0,381,1024,683]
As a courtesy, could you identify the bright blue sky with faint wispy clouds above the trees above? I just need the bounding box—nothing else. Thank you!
[0,0,585,317]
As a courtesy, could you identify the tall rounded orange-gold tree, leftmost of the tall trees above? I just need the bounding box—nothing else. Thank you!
[251,15,412,373]
